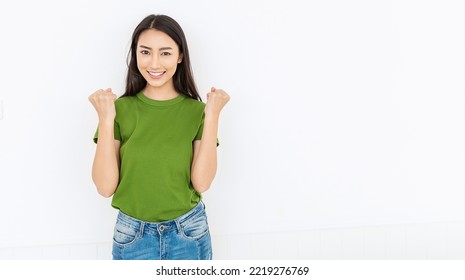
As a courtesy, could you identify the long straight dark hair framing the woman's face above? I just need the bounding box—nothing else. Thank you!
[121,15,202,101]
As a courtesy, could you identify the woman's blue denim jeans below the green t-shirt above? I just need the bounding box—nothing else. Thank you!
[113,201,212,260]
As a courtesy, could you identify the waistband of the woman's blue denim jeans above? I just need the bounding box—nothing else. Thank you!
[118,201,205,232]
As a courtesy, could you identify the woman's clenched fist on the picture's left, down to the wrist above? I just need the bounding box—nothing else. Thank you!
[89,88,116,123]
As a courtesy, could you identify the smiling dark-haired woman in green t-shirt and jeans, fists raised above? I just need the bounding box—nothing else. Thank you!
[89,15,229,259]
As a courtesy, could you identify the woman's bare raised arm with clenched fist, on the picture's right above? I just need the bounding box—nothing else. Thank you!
[191,88,230,193]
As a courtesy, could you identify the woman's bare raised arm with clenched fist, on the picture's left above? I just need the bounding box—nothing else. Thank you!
[89,89,120,197]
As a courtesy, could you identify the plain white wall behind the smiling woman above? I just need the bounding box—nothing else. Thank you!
[0,0,465,258]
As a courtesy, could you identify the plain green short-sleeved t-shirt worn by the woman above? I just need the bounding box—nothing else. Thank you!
[94,93,205,222]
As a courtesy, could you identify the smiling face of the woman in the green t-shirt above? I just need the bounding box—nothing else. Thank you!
[137,29,182,88]
